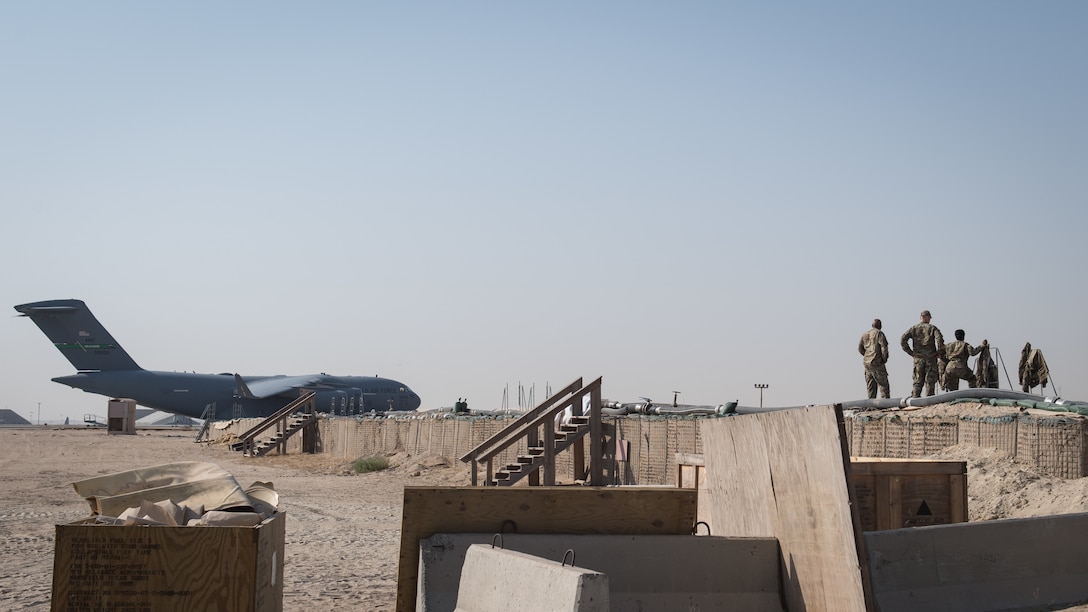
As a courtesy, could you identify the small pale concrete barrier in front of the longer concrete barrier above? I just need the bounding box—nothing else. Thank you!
[456,544,609,612]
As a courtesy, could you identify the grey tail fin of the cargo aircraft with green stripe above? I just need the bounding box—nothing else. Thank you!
[15,299,140,371]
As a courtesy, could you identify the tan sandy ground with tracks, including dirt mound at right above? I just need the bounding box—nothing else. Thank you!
[0,407,1088,612]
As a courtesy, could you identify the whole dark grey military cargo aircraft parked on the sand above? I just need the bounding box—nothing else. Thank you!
[15,299,420,418]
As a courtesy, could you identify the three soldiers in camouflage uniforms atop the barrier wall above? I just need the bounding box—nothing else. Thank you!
[857,310,990,399]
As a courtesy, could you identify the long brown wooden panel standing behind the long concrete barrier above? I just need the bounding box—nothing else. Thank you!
[397,487,697,612]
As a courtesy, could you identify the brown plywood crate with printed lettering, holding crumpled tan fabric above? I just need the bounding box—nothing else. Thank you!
[51,512,285,612]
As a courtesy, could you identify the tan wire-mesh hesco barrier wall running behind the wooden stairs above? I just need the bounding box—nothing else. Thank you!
[223,413,1088,485]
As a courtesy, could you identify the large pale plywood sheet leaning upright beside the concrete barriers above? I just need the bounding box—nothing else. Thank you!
[703,406,871,612]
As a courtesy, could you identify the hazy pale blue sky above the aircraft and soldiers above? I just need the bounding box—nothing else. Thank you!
[0,0,1088,421]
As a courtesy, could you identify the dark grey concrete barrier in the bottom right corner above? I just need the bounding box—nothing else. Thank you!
[864,514,1088,612]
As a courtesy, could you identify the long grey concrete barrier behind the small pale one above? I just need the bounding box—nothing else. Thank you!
[416,534,782,612]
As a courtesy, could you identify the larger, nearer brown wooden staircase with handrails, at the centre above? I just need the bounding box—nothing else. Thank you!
[460,378,604,487]
